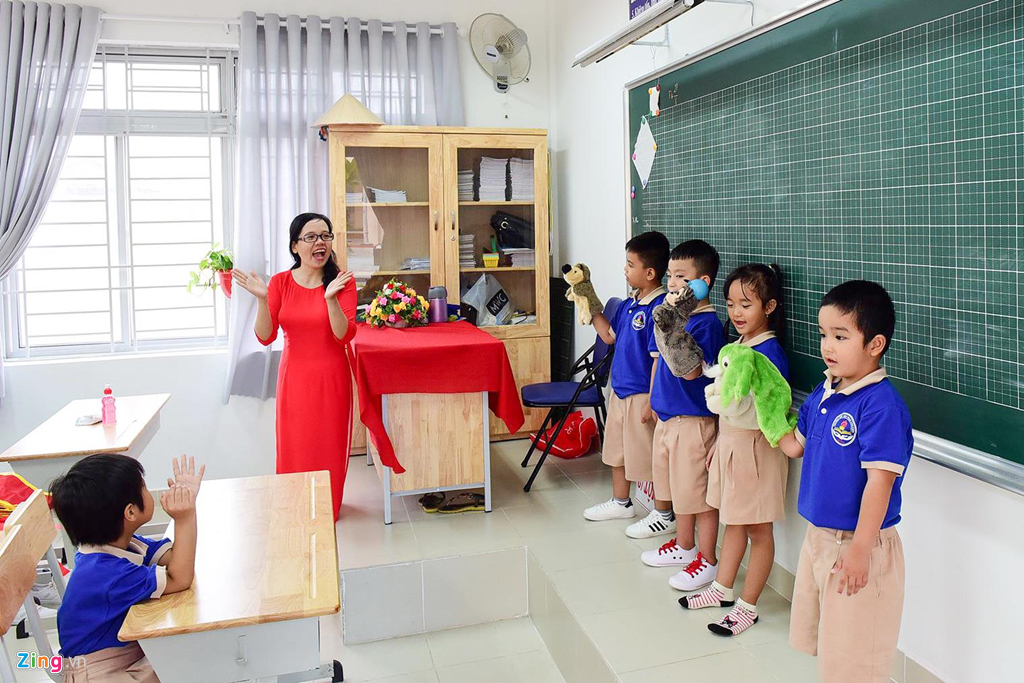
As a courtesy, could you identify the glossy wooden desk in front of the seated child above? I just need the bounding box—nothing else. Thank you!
[118,471,341,683]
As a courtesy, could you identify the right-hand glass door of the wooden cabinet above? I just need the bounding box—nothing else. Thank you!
[444,134,549,337]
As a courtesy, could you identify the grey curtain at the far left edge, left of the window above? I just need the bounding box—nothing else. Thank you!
[0,0,99,398]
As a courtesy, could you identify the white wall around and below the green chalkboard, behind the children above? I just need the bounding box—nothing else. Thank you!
[548,0,1024,683]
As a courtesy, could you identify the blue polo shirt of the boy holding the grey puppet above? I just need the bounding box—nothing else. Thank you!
[650,306,725,422]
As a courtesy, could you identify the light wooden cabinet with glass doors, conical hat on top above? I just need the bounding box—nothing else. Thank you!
[329,126,551,453]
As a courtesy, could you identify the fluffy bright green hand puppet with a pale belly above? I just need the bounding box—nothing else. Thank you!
[705,344,797,449]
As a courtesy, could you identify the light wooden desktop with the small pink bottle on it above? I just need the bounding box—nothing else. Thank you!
[0,393,171,565]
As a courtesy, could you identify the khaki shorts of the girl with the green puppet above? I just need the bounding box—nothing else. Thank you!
[708,420,790,524]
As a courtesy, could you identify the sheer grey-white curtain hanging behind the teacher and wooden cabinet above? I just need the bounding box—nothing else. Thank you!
[224,12,464,401]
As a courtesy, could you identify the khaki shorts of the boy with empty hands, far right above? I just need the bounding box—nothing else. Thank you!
[790,524,904,683]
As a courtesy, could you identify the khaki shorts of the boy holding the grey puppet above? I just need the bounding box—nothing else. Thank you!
[653,415,718,515]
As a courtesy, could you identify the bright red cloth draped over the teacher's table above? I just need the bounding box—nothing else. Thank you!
[351,322,524,474]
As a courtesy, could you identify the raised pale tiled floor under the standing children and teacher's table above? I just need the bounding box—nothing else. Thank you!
[338,441,817,683]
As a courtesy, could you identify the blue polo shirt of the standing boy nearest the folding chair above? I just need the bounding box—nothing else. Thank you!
[608,287,666,398]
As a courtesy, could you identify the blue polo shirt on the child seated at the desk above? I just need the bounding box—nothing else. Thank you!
[57,536,171,657]
